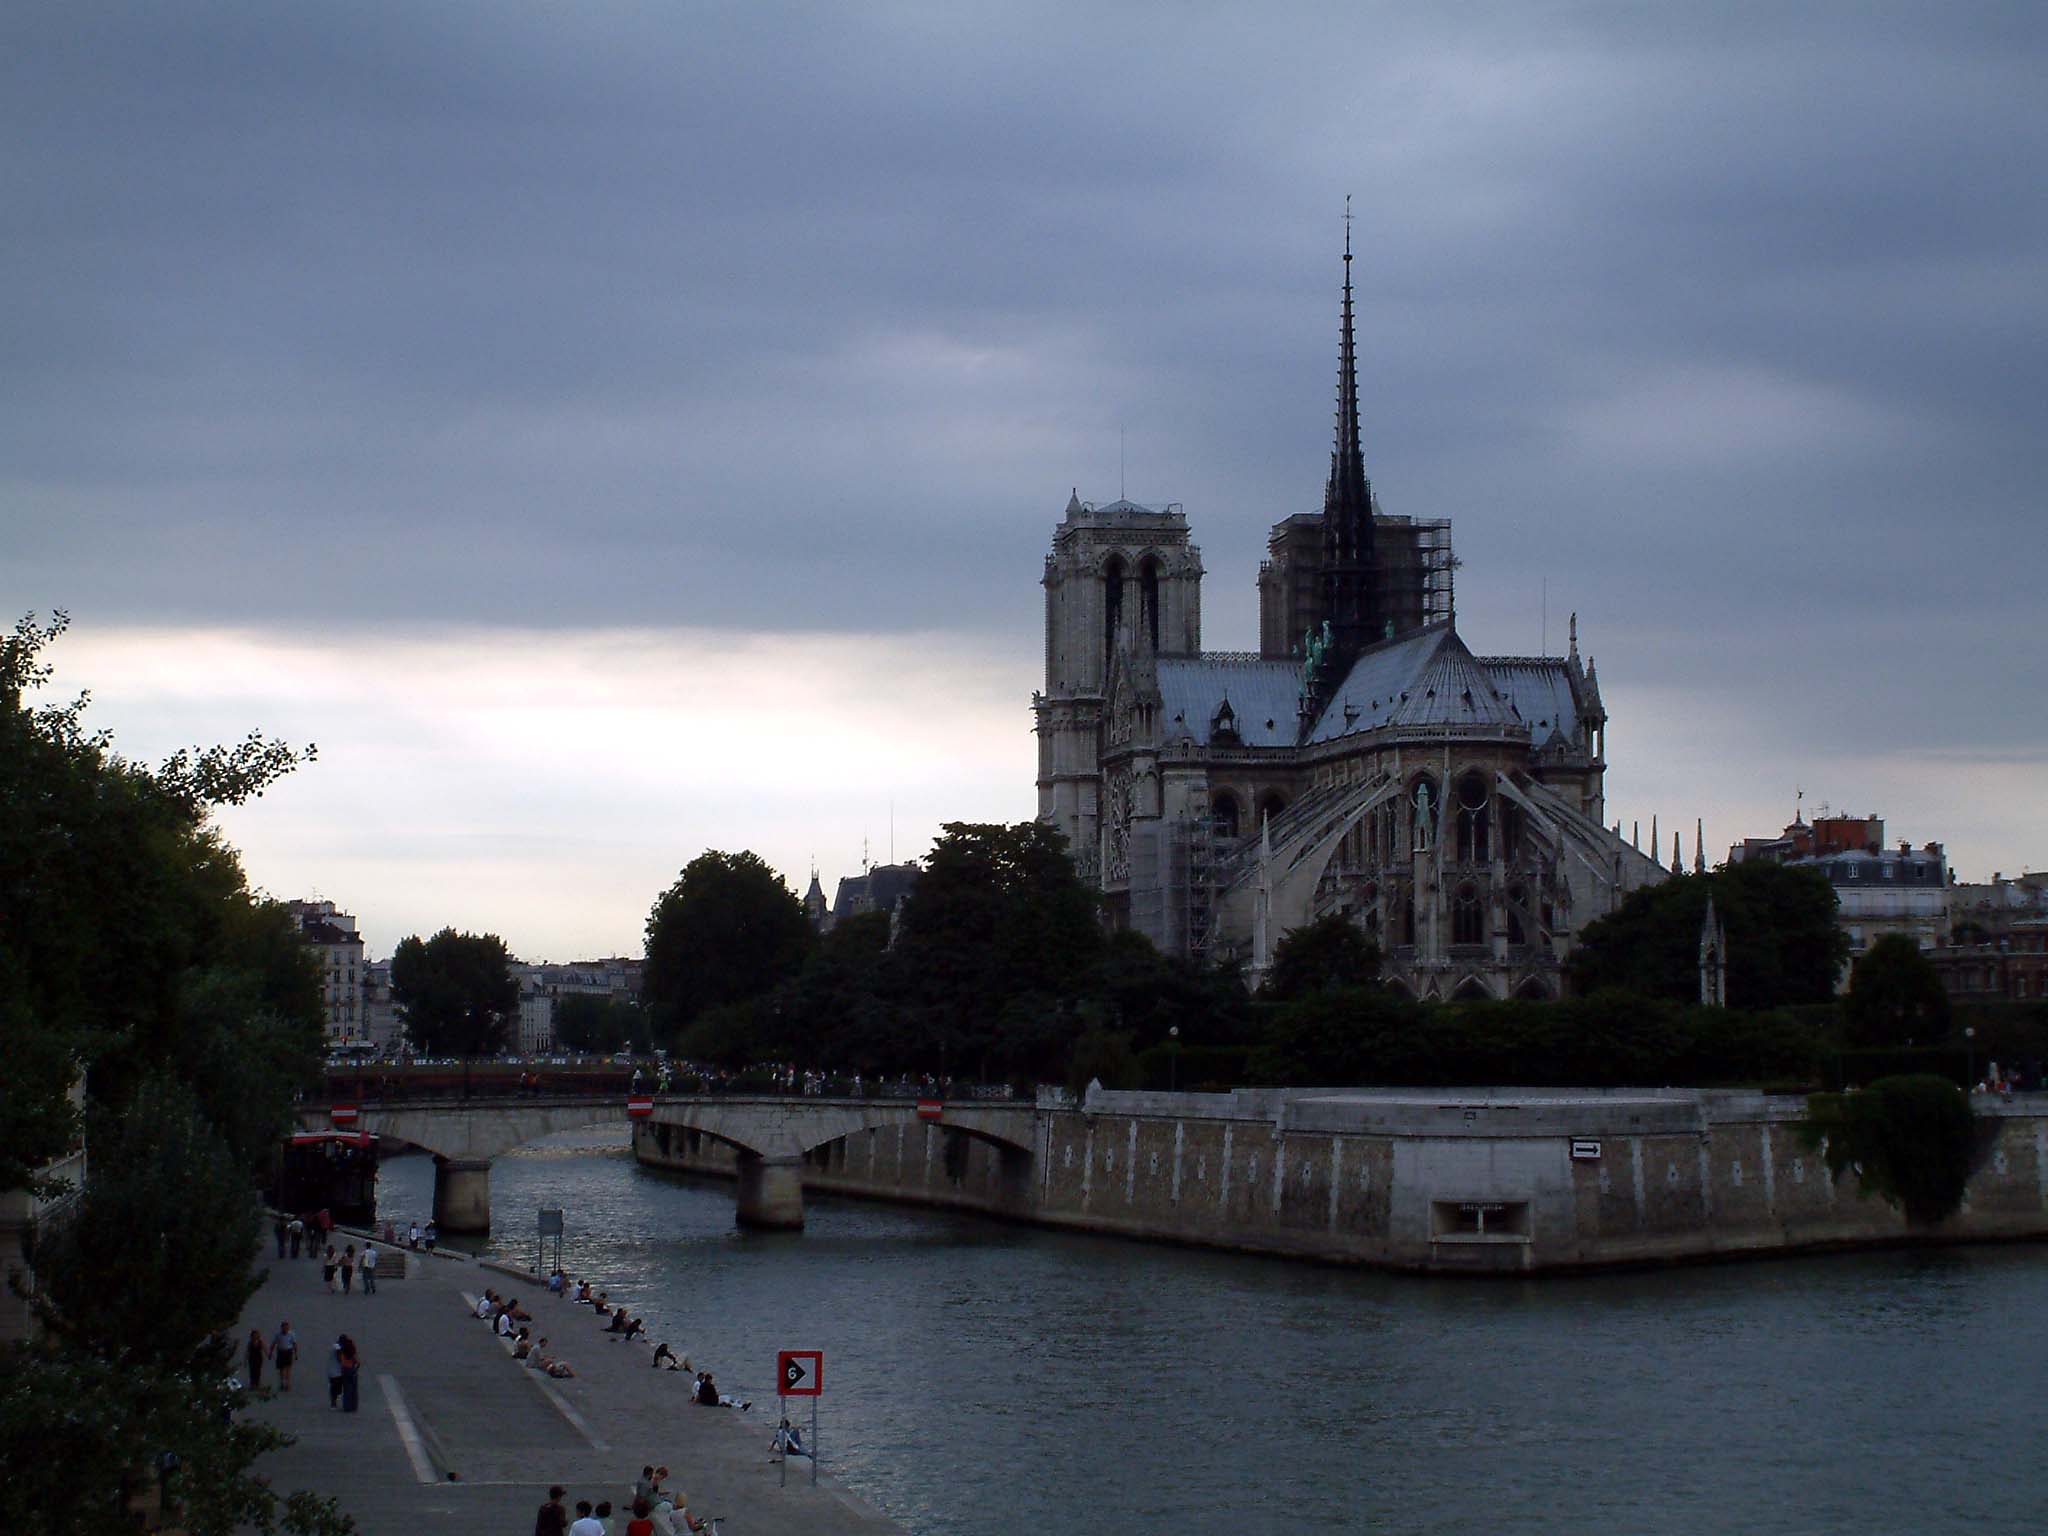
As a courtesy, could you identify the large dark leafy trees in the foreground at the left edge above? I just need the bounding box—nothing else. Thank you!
[0,614,350,1536]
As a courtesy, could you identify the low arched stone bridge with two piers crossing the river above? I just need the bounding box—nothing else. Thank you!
[299,1094,1036,1233]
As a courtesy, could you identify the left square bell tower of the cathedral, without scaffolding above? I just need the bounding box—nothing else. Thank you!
[1032,492,1202,879]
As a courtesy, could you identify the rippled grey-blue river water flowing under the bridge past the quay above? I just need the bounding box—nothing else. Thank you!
[379,1133,2048,1536]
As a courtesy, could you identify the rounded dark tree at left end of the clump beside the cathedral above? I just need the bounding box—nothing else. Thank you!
[641,848,811,1038]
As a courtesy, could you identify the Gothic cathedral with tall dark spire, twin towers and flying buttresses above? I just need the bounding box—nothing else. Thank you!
[1032,228,1663,997]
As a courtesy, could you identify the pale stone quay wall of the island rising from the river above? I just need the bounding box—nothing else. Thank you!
[633,1090,2048,1274]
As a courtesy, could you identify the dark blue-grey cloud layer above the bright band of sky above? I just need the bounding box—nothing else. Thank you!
[0,4,2048,765]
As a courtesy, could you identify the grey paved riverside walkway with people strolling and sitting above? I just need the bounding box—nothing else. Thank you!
[238,1239,901,1536]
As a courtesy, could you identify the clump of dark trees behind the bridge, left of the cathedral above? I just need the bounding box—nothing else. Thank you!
[645,821,1249,1083]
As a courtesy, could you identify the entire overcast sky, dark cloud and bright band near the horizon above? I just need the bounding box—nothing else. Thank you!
[0,0,2048,958]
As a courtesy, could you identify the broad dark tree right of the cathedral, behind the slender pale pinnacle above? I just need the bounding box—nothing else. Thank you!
[1571,860,1849,1008]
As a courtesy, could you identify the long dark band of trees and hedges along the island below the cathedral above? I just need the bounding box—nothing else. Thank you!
[638,823,2042,1090]
